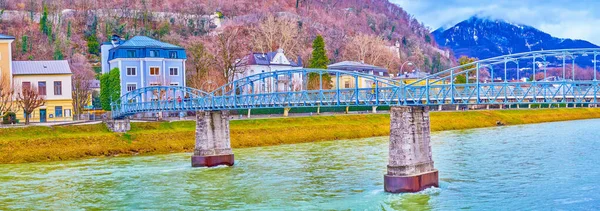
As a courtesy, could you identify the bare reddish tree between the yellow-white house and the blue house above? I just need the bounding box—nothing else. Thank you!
[71,54,94,119]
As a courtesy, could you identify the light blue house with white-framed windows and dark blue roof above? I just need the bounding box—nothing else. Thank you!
[101,35,186,95]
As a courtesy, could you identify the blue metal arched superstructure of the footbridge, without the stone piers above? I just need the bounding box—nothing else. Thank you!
[111,48,600,119]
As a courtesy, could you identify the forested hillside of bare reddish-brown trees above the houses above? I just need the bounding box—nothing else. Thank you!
[0,0,453,86]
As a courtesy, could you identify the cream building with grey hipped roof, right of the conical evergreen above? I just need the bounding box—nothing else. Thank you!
[327,61,389,89]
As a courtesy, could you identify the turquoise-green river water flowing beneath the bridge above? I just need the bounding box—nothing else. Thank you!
[0,120,600,210]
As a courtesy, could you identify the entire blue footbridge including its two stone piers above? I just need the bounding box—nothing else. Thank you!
[110,48,600,192]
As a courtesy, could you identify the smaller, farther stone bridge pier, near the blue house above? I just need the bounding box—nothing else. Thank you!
[192,111,234,167]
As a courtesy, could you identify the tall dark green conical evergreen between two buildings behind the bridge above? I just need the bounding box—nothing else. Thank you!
[308,35,331,90]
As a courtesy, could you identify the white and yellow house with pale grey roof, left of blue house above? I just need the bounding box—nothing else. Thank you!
[12,60,73,122]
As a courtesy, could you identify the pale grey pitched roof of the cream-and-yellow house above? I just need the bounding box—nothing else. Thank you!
[12,60,72,75]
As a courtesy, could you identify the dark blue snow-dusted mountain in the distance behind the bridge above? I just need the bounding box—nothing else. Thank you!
[432,16,598,59]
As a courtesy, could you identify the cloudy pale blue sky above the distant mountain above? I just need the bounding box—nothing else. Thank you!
[390,0,600,45]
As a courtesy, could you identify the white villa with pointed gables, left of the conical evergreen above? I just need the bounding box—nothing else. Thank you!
[235,49,302,93]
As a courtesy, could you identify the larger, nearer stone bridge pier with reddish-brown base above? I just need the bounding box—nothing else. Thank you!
[384,106,439,193]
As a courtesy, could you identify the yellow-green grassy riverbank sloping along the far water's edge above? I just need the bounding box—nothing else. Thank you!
[0,108,600,163]
